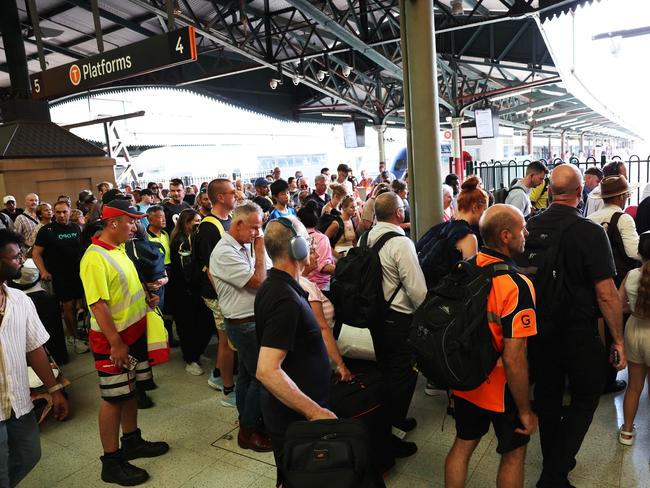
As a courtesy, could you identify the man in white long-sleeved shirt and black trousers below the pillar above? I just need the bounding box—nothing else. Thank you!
[360,192,427,457]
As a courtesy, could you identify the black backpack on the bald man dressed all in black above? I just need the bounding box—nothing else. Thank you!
[515,215,583,337]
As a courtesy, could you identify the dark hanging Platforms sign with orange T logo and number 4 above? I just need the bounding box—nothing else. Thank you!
[30,26,197,100]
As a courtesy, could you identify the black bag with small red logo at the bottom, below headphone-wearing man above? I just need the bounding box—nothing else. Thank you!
[281,419,384,488]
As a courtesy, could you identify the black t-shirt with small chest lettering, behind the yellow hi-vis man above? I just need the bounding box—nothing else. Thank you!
[34,222,82,276]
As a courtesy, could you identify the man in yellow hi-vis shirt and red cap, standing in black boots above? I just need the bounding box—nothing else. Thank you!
[80,199,169,486]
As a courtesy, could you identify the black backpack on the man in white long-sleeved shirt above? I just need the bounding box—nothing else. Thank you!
[331,232,405,328]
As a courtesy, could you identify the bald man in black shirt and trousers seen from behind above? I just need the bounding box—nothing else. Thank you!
[522,164,626,488]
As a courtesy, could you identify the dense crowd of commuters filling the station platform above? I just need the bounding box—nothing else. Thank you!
[0,158,650,488]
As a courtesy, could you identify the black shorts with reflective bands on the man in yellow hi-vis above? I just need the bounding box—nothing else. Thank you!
[93,333,155,403]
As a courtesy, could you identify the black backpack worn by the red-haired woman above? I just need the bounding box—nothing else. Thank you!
[415,220,472,289]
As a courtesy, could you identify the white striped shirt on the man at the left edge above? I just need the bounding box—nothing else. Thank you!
[0,285,50,421]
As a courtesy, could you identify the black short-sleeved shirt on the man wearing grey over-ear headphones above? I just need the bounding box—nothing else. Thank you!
[255,268,331,434]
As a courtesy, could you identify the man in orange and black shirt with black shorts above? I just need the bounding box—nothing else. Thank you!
[445,204,537,488]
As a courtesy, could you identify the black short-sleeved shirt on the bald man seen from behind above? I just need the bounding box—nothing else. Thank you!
[527,203,616,319]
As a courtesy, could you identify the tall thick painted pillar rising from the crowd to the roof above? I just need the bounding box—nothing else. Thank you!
[400,0,442,240]
